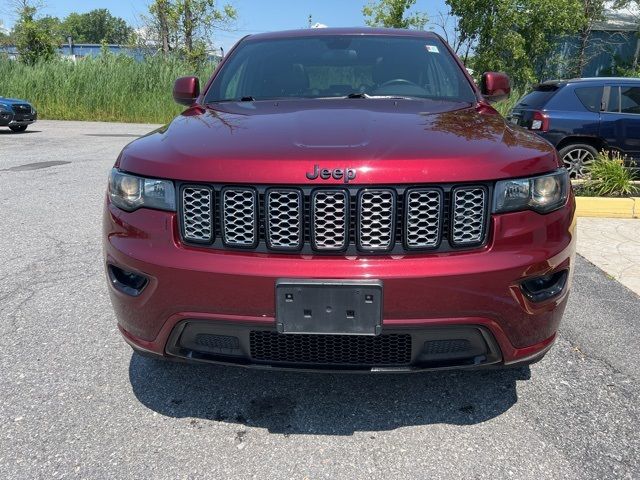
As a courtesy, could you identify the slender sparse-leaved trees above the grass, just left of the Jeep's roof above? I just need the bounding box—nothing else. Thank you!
[147,0,237,63]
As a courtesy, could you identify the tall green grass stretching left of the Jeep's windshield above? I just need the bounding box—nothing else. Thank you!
[0,54,214,123]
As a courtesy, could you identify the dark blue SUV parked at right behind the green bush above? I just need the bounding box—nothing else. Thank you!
[507,78,640,178]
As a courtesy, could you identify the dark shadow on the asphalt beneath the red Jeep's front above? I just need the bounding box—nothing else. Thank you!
[129,353,531,435]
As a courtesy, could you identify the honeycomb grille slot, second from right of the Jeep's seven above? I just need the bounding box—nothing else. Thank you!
[405,188,443,248]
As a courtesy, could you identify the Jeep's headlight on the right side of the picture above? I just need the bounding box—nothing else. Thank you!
[493,169,569,213]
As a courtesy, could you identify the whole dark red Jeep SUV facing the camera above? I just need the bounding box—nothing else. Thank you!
[104,29,575,372]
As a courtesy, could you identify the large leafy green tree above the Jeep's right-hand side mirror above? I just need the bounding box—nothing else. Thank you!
[446,0,583,88]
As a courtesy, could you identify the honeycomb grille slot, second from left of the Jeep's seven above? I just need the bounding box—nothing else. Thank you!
[221,187,258,247]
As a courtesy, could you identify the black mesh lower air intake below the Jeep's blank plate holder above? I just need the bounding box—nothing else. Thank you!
[250,330,411,366]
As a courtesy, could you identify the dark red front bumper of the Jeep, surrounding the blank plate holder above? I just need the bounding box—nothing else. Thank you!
[104,197,575,371]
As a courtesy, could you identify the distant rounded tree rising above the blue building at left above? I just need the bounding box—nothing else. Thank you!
[60,8,133,44]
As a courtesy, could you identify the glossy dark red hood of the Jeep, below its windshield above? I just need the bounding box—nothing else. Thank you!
[118,99,559,184]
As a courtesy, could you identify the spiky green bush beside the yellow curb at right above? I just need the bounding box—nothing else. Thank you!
[580,151,639,197]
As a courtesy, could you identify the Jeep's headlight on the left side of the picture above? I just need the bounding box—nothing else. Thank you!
[109,168,176,212]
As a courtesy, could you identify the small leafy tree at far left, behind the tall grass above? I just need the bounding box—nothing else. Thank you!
[13,0,57,65]
